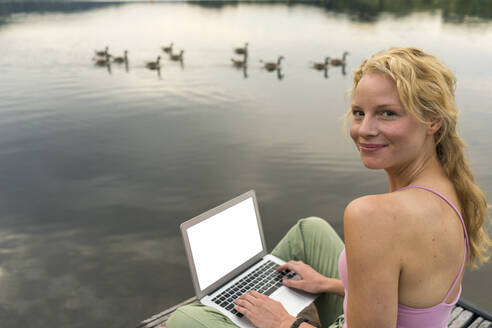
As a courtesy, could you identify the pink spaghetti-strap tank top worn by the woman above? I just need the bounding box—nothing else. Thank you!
[338,186,469,328]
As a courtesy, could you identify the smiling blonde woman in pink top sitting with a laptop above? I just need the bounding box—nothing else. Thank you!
[168,48,492,328]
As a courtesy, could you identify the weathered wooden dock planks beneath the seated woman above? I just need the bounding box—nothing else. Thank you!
[137,297,492,328]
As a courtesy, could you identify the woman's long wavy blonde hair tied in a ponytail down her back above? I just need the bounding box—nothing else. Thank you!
[346,48,492,268]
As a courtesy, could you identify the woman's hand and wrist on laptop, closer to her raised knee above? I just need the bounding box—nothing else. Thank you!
[277,261,344,296]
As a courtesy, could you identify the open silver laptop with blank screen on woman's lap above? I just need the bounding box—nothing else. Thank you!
[180,190,318,328]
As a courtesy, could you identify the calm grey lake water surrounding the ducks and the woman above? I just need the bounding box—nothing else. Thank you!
[0,1,492,328]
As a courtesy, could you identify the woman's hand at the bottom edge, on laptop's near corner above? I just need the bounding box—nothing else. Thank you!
[234,290,296,328]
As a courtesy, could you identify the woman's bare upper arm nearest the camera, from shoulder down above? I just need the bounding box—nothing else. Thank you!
[344,195,402,328]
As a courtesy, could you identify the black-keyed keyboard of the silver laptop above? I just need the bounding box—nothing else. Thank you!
[212,261,295,317]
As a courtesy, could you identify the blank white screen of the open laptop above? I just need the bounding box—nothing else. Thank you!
[187,197,263,290]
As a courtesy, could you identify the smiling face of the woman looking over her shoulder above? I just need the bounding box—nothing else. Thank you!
[350,73,428,170]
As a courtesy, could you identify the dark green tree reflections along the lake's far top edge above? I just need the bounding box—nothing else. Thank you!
[0,0,492,24]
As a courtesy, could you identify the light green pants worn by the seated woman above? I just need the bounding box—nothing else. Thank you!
[166,217,344,328]
